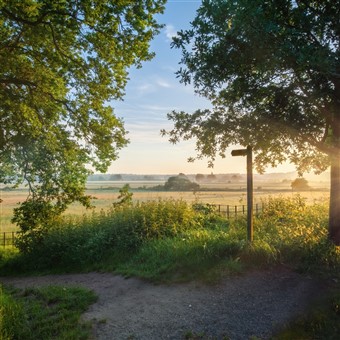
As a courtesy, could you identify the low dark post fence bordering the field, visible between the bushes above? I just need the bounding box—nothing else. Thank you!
[0,203,264,247]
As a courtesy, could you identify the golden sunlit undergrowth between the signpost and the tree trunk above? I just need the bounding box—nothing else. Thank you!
[255,195,340,273]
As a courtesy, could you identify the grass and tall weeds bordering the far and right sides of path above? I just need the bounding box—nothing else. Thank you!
[0,196,340,339]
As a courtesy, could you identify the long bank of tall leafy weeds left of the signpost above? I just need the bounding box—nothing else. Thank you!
[11,200,226,269]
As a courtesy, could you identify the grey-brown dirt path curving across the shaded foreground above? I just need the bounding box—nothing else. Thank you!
[0,268,321,340]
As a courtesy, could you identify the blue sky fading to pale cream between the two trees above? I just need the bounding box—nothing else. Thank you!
[107,0,294,174]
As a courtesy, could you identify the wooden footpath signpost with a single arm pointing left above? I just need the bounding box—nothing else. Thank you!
[231,146,254,242]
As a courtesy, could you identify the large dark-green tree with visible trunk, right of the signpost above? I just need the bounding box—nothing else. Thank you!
[163,0,340,245]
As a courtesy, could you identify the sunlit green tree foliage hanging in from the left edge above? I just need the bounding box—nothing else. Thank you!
[0,0,165,247]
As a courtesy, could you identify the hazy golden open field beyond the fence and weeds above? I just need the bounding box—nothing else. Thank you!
[0,180,329,232]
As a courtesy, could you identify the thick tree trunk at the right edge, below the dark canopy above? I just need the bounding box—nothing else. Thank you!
[329,152,340,245]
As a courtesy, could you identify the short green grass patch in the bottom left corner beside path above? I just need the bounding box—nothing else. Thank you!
[0,287,96,340]
